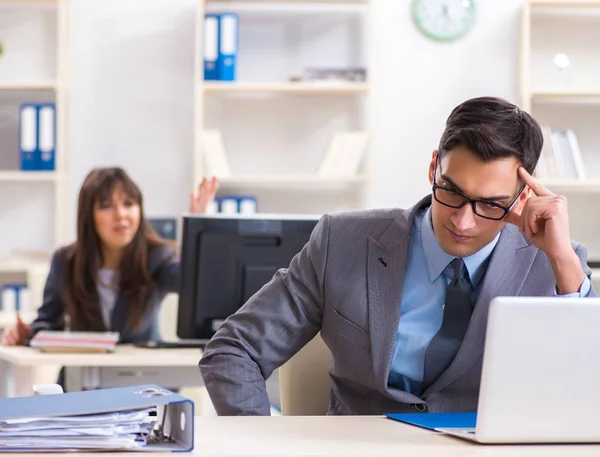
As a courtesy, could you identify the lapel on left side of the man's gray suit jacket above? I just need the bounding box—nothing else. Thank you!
[367,198,431,391]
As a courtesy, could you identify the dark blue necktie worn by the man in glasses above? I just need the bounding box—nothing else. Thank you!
[423,258,473,390]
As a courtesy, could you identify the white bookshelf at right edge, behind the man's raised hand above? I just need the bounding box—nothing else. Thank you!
[519,0,600,261]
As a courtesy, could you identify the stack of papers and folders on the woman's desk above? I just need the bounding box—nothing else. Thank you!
[29,330,119,352]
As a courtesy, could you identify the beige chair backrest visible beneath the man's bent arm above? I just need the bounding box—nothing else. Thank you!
[279,333,331,416]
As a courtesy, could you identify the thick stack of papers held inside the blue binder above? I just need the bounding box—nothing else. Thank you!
[0,407,157,451]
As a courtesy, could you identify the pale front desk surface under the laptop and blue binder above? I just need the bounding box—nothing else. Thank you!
[5,416,600,457]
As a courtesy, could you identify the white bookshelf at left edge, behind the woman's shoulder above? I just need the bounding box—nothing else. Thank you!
[0,0,69,305]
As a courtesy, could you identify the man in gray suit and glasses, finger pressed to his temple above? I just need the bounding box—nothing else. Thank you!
[200,97,596,415]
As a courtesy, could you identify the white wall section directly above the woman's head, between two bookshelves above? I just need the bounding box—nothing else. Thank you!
[69,0,196,237]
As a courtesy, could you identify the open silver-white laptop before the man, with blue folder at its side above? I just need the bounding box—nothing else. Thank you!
[390,297,600,444]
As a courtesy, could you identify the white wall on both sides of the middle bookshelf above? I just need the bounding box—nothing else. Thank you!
[70,0,524,233]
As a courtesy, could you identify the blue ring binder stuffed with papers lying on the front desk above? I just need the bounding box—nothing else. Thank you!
[0,384,194,453]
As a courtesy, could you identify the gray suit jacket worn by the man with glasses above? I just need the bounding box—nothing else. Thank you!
[200,197,596,415]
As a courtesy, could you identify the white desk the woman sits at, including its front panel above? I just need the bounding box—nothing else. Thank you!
[0,346,202,397]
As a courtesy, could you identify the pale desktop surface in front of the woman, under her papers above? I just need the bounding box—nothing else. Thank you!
[0,345,202,367]
